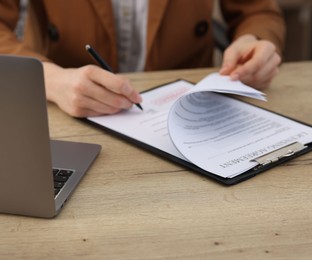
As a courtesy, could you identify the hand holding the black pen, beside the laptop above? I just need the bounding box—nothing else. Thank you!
[43,62,142,117]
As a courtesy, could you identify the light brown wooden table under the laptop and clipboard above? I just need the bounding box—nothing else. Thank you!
[0,62,312,259]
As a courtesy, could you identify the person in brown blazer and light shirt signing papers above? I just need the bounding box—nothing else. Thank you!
[0,0,285,117]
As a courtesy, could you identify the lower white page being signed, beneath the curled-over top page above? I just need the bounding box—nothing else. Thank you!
[88,81,194,159]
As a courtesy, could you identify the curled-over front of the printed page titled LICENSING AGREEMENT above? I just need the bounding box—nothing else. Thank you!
[168,92,312,178]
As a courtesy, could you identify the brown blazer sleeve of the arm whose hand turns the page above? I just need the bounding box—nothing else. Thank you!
[220,0,285,54]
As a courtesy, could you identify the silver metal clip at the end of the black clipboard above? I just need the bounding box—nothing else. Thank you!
[252,142,307,166]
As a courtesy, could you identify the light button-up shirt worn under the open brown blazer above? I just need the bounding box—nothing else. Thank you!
[111,0,148,72]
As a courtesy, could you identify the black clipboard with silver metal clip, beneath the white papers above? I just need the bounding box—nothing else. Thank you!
[82,80,312,185]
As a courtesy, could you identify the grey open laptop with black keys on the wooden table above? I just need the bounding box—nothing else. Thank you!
[0,55,101,218]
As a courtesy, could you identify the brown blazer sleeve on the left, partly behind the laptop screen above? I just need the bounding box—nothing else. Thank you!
[0,0,48,61]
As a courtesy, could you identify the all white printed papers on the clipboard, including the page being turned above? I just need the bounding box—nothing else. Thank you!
[88,73,312,178]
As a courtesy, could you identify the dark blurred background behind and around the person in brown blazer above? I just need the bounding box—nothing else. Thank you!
[16,0,312,66]
